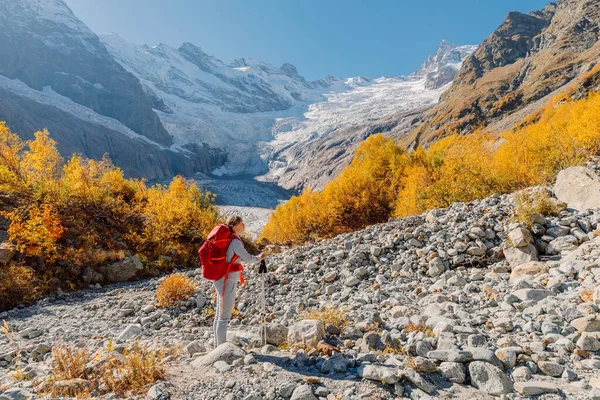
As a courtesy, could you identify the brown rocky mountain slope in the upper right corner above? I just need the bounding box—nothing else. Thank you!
[407,0,600,145]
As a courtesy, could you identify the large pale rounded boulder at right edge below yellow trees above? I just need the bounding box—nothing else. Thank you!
[554,167,600,210]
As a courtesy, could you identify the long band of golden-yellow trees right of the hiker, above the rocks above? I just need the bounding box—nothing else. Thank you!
[261,93,600,243]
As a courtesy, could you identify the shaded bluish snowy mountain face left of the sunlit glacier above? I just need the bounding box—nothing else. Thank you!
[101,34,353,175]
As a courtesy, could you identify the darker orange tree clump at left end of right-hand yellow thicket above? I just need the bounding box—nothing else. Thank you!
[261,135,406,242]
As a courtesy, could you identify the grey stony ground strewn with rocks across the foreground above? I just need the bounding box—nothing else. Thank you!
[0,164,600,400]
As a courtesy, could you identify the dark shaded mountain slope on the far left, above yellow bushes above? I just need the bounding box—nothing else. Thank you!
[0,0,224,178]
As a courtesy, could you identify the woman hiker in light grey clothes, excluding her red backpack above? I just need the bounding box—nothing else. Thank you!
[213,216,266,347]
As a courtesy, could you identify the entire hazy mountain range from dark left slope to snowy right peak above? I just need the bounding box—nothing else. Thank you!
[0,0,473,195]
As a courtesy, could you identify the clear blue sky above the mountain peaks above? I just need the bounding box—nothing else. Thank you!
[65,0,547,80]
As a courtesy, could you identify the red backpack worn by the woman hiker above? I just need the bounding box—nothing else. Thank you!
[198,225,239,281]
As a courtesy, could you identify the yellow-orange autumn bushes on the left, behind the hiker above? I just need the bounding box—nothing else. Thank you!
[0,123,220,309]
